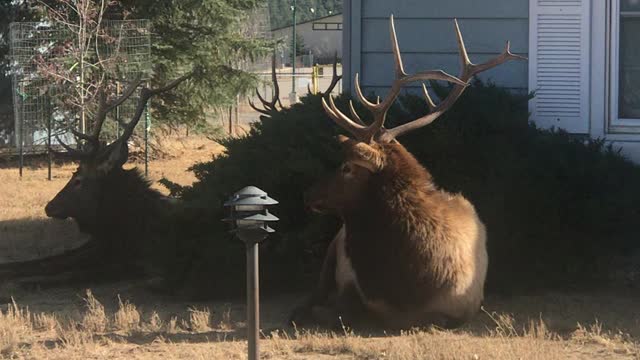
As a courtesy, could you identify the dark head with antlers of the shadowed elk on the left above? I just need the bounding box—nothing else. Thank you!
[45,73,192,223]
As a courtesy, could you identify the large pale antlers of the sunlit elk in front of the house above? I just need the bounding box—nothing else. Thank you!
[322,15,526,143]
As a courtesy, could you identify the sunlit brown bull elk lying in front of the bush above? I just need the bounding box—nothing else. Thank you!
[292,16,523,328]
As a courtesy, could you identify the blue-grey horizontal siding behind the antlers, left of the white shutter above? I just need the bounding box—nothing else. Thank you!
[343,0,529,94]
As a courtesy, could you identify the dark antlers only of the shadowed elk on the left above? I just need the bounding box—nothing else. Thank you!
[56,72,193,160]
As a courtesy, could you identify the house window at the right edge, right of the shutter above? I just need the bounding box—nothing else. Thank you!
[611,0,640,127]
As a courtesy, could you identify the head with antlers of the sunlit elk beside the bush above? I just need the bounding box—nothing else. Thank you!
[305,15,525,214]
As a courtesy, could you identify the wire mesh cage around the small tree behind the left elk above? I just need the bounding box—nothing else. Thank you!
[9,19,151,179]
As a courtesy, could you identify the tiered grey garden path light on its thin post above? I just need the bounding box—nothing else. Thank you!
[224,186,278,360]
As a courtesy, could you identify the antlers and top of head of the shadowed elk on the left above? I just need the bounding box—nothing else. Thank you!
[52,72,193,167]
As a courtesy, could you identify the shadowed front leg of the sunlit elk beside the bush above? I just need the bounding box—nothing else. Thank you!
[289,238,337,324]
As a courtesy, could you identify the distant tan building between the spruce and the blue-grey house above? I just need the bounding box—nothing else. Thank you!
[273,14,342,59]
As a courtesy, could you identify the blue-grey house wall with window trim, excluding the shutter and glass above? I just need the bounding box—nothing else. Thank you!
[343,0,640,164]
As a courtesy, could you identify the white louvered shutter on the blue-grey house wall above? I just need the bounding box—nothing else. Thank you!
[529,0,591,133]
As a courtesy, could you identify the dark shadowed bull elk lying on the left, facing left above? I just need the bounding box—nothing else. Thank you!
[0,73,191,279]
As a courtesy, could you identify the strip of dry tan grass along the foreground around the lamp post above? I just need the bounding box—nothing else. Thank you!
[0,284,640,360]
